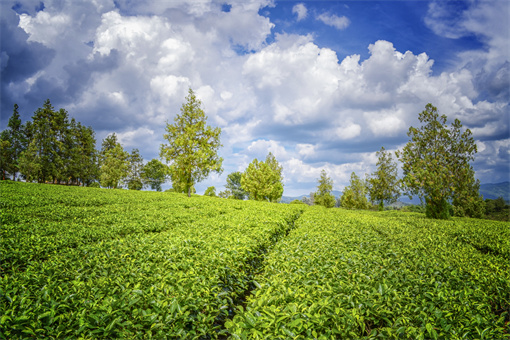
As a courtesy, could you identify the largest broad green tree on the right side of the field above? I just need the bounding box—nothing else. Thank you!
[397,104,479,219]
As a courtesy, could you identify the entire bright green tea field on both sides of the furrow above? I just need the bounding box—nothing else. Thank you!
[0,181,510,339]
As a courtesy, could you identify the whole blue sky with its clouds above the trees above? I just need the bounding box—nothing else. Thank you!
[0,0,510,196]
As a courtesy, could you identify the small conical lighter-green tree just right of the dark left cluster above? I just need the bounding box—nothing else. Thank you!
[99,133,129,189]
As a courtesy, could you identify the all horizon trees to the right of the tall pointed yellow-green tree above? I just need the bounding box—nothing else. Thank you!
[206,104,486,219]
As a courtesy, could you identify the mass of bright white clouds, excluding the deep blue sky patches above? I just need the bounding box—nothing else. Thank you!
[6,0,508,194]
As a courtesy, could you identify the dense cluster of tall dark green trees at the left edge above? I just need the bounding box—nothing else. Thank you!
[0,99,98,185]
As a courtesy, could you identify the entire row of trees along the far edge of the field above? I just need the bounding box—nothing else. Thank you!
[0,95,494,219]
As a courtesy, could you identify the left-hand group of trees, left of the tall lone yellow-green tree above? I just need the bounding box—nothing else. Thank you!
[0,99,168,190]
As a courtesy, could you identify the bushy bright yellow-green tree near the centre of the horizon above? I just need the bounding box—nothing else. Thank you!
[241,153,283,202]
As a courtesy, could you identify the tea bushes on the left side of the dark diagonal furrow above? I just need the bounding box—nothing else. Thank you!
[0,181,302,339]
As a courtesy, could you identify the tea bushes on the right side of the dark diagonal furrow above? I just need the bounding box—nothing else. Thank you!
[225,207,510,339]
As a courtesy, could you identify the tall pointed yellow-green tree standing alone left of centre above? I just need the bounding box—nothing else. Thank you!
[160,88,223,197]
